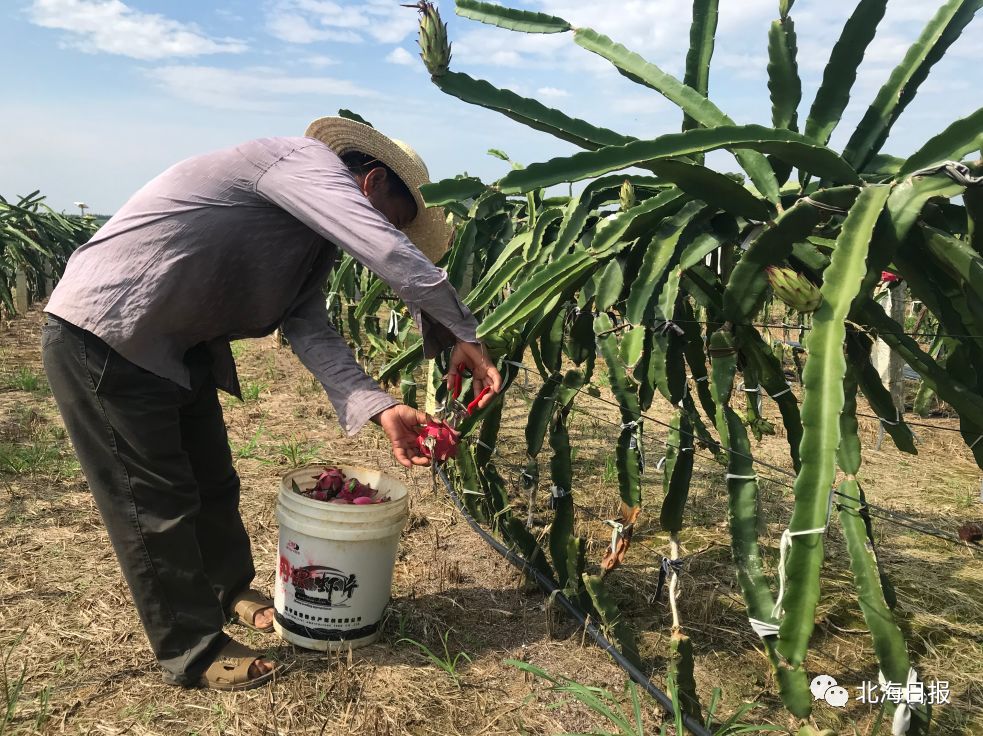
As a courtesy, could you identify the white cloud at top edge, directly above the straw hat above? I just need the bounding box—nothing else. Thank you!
[267,0,417,44]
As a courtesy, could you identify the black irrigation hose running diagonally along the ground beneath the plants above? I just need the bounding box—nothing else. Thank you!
[437,468,712,736]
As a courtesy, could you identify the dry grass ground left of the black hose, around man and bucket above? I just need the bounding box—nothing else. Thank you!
[0,306,660,736]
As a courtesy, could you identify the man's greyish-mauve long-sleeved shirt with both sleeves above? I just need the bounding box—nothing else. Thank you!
[46,138,477,434]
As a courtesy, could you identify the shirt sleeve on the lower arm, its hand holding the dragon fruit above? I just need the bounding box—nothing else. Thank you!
[281,292,399,435]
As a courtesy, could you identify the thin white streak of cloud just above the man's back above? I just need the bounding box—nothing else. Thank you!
[147,65,376,112]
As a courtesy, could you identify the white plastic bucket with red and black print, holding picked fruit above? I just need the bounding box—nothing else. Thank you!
[273,465,409,651]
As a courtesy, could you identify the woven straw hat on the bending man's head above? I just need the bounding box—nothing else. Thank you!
[304,117,453,262]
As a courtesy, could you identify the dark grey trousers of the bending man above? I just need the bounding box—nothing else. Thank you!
[41,316,255,685]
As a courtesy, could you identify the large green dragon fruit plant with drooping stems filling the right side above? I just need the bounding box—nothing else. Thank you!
[332,0,983,734]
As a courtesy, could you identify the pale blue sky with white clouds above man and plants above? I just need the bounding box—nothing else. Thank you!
[0,0,983,213]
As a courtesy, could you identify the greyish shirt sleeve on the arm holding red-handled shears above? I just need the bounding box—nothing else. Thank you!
[256,140,478,358]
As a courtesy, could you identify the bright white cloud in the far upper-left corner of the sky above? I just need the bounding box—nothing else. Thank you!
[28,0,247,60]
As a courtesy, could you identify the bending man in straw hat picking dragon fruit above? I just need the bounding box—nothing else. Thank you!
[42,118,501,690]
